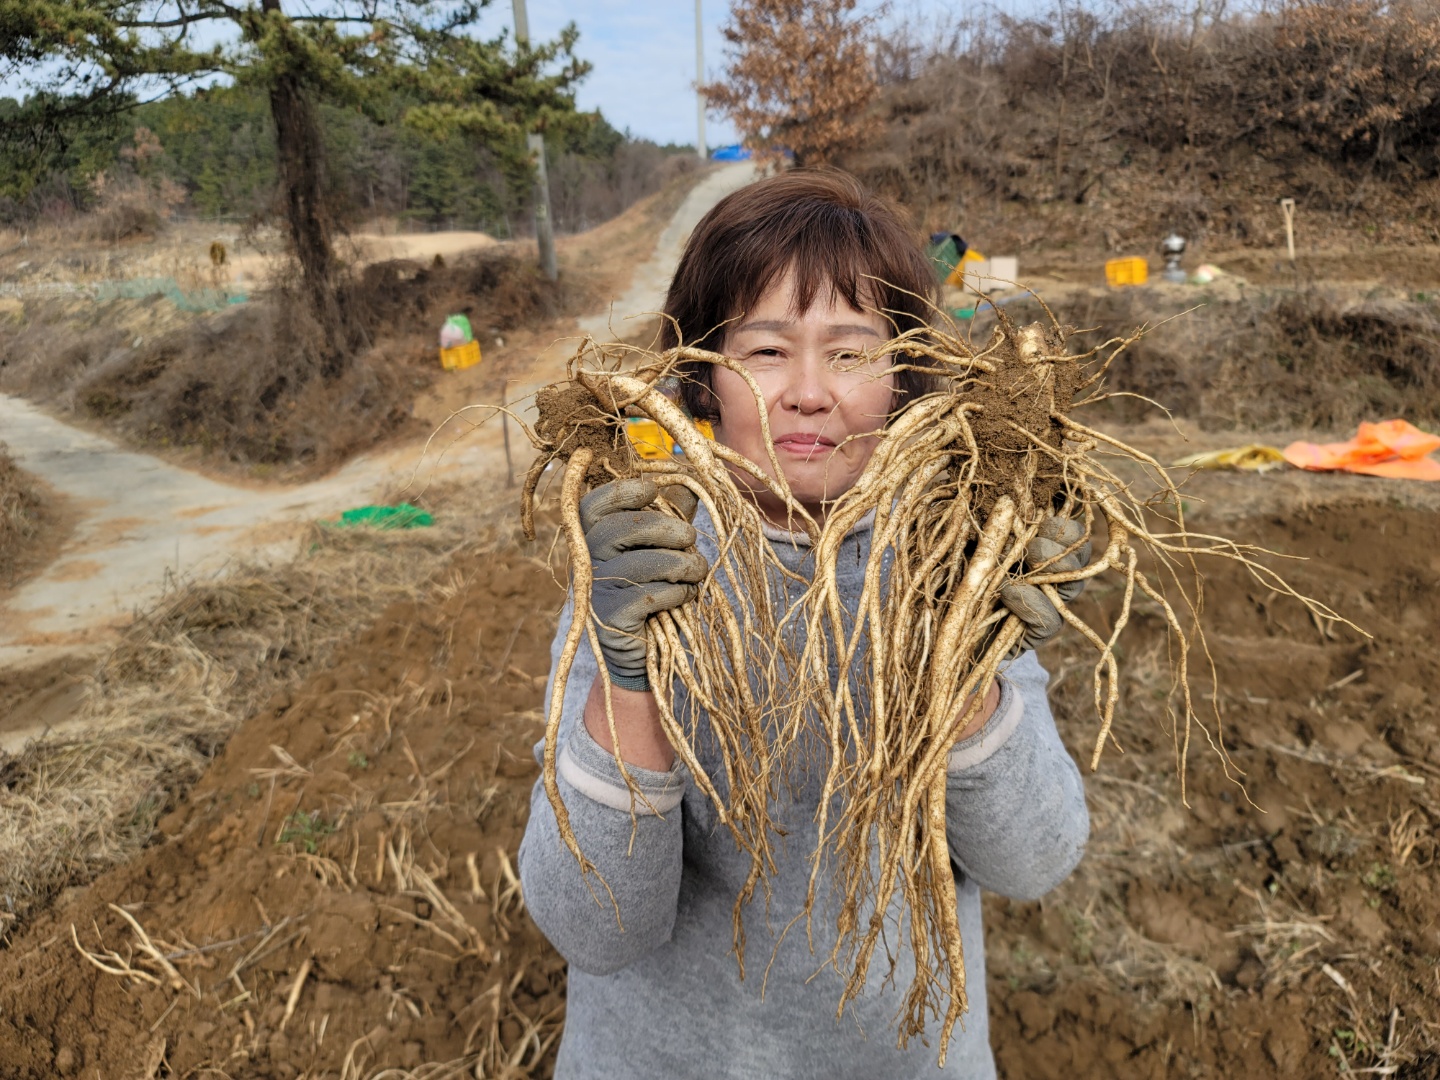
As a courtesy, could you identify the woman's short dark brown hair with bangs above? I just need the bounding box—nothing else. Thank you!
[662,168,936,420]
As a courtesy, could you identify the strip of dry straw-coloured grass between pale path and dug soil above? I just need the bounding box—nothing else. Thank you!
[0,480,506,936]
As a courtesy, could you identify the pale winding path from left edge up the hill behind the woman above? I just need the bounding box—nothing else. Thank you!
[0,164,753,750]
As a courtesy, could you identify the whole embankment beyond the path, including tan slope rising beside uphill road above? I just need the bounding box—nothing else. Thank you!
[0,170,703,478]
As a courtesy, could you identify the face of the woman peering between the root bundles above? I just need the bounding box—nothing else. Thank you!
[711,274,894,523]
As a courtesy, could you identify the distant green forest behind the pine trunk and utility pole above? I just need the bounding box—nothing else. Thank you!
[0,86,694,238]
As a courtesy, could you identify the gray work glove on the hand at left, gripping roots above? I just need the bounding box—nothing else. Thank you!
[580,478,710,690]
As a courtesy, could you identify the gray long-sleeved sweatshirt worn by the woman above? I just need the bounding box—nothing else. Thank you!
[520,508,1090,1080]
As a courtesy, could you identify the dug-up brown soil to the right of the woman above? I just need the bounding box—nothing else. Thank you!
[986,498,1440,1077]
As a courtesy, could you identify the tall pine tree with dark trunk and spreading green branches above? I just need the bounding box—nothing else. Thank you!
[0,0,592,360]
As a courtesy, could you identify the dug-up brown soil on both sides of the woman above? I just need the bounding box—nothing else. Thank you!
[0,477,1440,1080]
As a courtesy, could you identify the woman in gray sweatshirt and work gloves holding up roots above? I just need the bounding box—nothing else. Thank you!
[520,170,1089,1080]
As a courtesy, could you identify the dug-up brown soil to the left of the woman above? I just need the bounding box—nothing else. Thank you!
[0,549,564,1080]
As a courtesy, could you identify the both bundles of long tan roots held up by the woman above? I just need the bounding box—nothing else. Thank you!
[523,314,1342,1063]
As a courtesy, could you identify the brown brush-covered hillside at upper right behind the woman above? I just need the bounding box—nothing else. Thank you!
[844,0,1440,253]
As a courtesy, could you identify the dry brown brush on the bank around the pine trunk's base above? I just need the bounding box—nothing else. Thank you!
[0,251,577,474]
